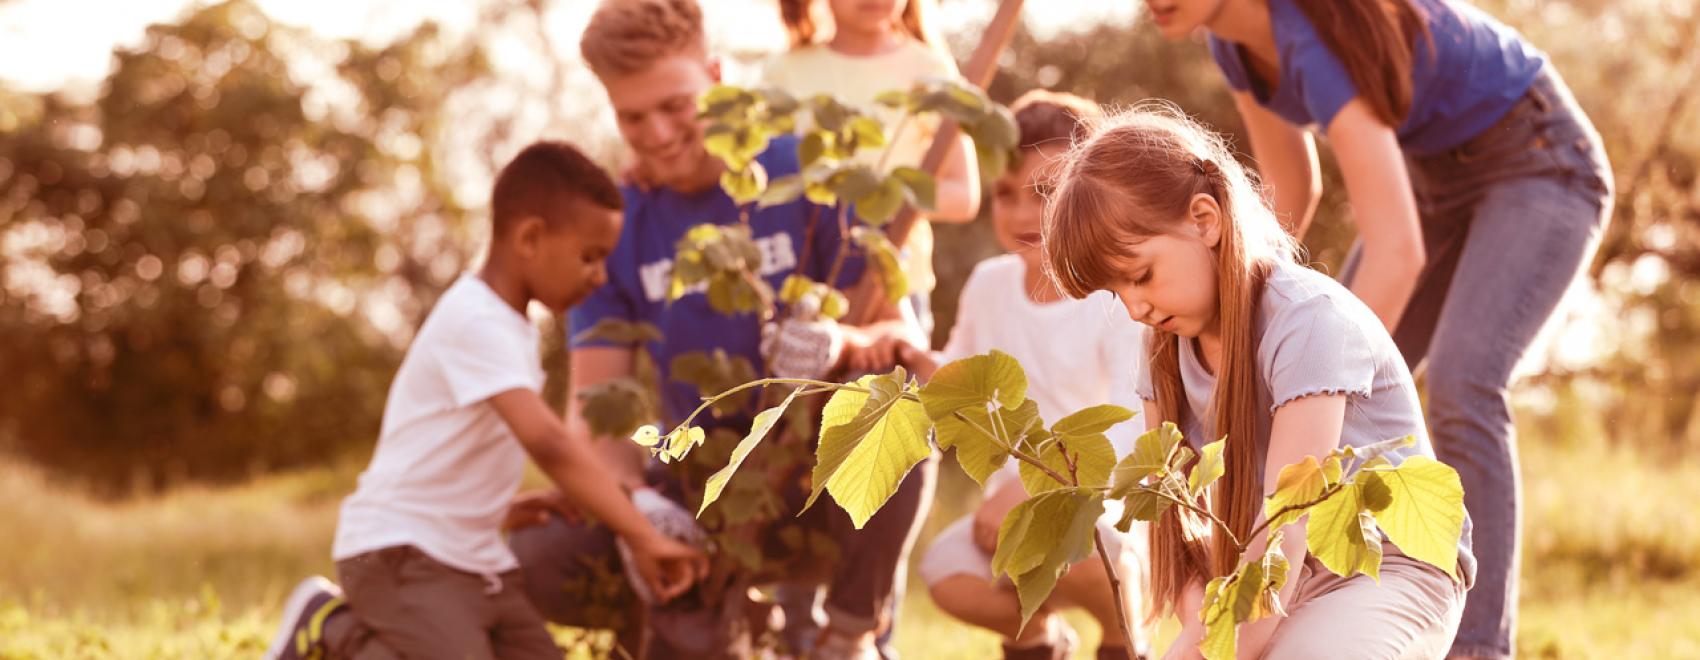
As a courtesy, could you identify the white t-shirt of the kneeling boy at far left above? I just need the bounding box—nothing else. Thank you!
[332,274,544,575]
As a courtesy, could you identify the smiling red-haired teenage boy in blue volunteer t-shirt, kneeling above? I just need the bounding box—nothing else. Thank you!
[512,0,932,657]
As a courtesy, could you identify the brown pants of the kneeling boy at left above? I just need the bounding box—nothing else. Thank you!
[325,546,561,660]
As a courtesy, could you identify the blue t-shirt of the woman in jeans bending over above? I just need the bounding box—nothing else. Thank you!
[1210,0,1547,155]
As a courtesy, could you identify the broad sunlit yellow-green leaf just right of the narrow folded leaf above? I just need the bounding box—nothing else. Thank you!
[802,367,932,529]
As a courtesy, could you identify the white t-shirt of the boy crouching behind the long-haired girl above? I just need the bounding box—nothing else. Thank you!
[942,253,1146,492]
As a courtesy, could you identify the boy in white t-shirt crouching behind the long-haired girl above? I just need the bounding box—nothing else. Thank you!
[867,90,1146,658]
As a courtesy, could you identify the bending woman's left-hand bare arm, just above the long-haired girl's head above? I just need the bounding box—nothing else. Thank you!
[1234,92,1323,240]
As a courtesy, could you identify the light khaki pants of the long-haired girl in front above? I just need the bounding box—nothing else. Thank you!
[1263,544,1464,660]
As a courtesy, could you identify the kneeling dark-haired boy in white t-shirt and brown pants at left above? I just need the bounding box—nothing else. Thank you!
[265,143,707,658]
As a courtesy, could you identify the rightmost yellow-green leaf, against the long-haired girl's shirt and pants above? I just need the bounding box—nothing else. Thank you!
[1358,456,1464,577]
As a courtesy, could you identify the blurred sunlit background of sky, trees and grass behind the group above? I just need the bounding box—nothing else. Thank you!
[0,0,1700,658]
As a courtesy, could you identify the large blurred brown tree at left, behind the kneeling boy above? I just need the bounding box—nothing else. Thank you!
[0,0,488,492]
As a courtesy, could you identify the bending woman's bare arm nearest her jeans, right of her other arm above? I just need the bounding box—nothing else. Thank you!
[1328,99,1428,332]
